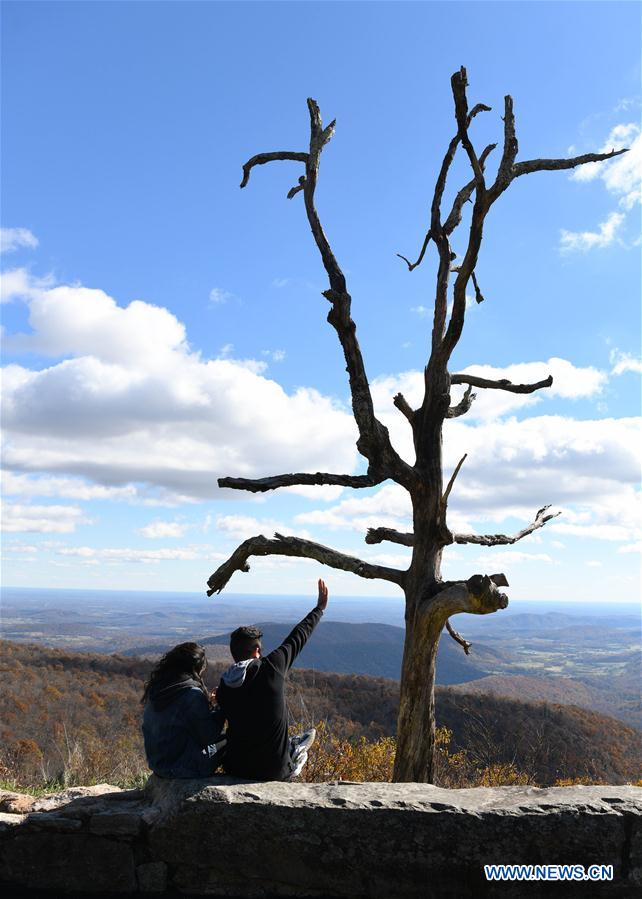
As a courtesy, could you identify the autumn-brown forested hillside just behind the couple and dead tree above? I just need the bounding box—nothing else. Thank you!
[0,641,641,786]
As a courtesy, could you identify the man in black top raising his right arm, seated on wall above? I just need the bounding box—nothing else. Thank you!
[217,580,328,780]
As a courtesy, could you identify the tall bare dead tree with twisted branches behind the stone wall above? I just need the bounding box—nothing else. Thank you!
[208,68,625,782]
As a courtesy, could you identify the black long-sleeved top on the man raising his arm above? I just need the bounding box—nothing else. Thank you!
[216,607,323,780]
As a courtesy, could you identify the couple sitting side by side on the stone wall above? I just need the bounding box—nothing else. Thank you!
[143,580,328,780]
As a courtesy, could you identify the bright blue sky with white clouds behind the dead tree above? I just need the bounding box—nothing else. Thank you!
[2,2,640,601]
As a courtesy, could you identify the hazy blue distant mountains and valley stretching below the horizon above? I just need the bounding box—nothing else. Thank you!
[1,588,642,728]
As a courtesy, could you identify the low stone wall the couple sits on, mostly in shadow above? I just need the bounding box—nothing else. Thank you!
[0,777,642,899]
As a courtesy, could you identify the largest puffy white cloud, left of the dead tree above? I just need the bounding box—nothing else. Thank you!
[3,285,357,500]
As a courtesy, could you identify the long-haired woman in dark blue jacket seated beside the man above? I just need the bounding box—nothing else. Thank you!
[141,643,225,777]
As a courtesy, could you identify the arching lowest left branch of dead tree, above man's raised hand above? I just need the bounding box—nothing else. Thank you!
[207,534,405,596]
